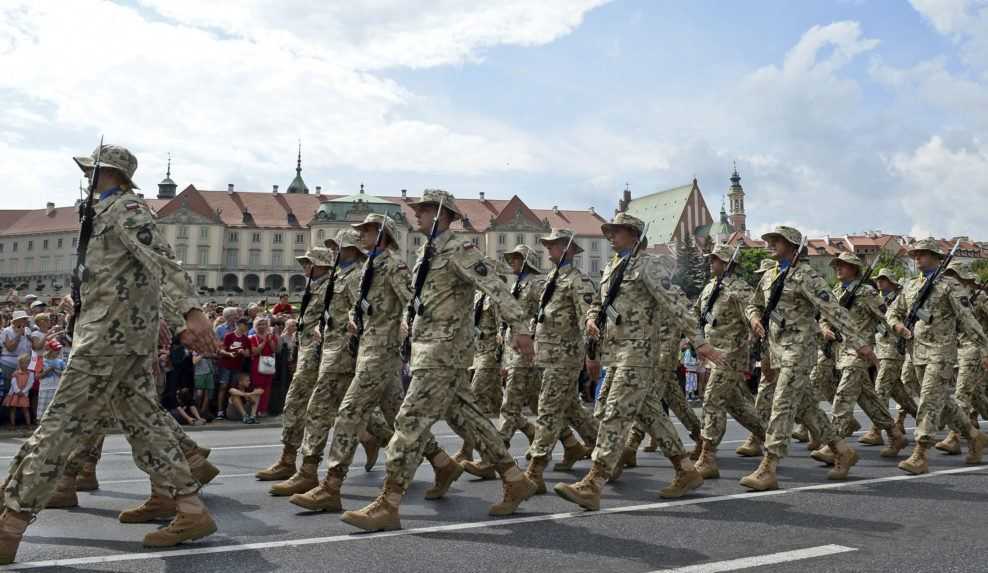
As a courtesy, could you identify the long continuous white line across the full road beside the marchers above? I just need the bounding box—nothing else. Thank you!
[0,466,986,571]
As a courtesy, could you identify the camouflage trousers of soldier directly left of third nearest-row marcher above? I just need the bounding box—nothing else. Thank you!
[528,366,598,458]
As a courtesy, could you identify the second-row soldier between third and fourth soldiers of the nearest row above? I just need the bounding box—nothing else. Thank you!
[694,245,765,479]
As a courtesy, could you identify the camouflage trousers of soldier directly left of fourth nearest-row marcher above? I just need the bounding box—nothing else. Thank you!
[701,366,765,448]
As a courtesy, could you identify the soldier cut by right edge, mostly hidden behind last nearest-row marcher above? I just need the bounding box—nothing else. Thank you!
[936,260,988,455]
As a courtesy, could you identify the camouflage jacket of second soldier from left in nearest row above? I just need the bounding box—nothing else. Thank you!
[411,231,526,369]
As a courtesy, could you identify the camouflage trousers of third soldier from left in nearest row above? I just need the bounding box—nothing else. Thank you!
[592,367,685,475]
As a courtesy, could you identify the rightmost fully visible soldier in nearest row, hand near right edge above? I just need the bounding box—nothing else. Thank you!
[888,239,988,474]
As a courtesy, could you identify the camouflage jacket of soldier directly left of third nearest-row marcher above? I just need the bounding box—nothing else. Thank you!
[533,264,597,366]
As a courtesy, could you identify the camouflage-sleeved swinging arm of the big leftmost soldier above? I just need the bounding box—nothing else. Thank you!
[110,196,199,332]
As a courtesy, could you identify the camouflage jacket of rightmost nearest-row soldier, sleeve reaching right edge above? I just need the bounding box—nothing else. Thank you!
[889,276,988,366]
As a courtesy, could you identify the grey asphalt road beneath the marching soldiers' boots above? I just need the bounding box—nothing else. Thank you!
[0,408,988,573]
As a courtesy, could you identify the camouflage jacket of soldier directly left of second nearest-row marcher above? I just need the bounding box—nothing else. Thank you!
[347,250,412,365]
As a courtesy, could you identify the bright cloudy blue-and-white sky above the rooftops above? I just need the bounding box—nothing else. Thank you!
[0,0,988,240]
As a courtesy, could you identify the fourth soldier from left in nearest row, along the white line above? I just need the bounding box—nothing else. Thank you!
[741,226,877,491]
